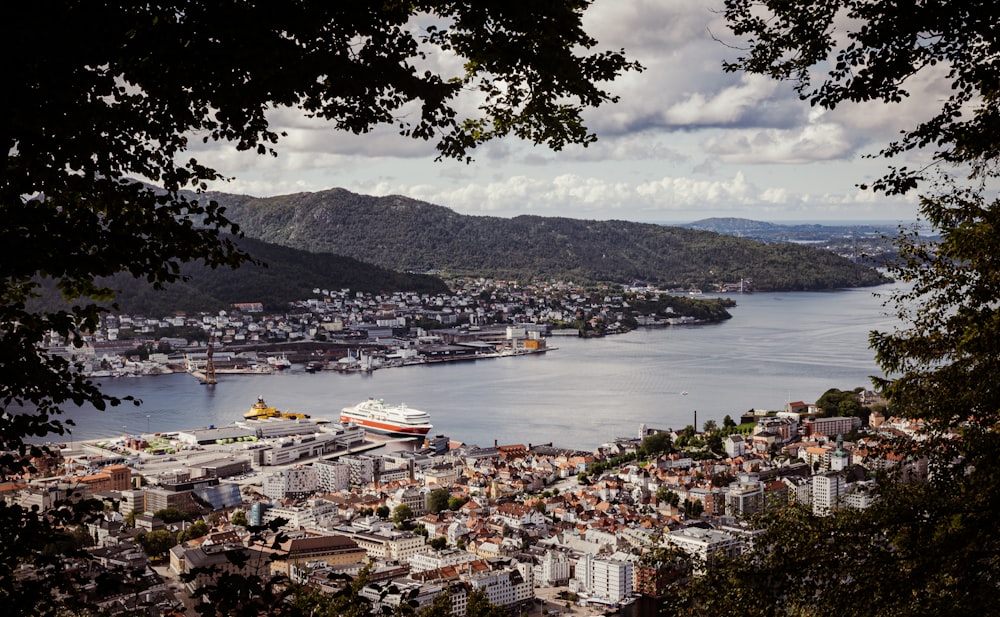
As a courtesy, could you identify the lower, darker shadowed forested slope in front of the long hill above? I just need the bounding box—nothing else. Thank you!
[29,238,448,316]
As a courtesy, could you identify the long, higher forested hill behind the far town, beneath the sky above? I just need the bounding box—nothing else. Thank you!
[211,189,884,290]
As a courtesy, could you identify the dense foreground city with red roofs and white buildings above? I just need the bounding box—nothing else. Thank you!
[3,346,908,616]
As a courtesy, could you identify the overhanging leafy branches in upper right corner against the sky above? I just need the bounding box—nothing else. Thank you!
[725,0,1000,194]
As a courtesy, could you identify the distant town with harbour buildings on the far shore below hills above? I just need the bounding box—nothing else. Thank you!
[48,279,736,381]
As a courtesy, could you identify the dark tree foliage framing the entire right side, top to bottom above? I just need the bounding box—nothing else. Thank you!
[672,0,1000,616]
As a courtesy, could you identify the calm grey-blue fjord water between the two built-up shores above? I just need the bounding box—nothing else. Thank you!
[62,285,896,450]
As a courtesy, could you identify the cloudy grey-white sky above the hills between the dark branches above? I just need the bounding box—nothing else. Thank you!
[199,0,941,223]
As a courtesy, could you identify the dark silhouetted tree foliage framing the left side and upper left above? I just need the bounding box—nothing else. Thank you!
[0,0,640,614]
